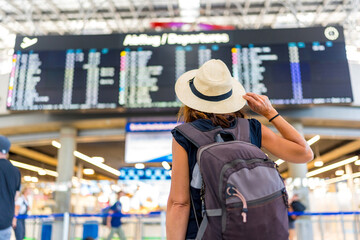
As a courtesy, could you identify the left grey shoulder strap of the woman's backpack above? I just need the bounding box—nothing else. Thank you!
[175,123,222,148]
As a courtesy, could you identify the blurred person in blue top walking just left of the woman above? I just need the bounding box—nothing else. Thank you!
[107,191,126,240]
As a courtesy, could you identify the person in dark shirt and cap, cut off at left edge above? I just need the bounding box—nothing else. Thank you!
[0,135,21,240]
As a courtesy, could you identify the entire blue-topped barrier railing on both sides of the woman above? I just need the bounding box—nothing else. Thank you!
[14,211,360,240]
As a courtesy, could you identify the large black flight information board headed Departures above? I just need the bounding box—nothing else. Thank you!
[7,27,353,110]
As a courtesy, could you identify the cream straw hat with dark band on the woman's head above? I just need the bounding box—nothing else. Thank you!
[175,59,246,114]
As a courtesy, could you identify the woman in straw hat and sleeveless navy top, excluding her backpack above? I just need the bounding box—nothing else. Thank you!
[166,60,313,240]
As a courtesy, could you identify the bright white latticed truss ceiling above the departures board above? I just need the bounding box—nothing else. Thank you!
[0,0,360,49]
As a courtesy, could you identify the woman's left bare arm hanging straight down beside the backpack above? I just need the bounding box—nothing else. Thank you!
[166,139,190,240]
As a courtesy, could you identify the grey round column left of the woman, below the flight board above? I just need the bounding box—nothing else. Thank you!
[52,126,77,240]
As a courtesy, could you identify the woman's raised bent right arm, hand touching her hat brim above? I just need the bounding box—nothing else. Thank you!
[244,93,314,163]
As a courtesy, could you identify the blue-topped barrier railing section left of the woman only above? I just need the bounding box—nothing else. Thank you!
[17,212,166,240]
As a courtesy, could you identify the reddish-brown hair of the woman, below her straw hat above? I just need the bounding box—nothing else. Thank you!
[178,105,246,128]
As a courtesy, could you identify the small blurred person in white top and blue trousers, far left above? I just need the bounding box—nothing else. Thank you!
[14,187,30,240]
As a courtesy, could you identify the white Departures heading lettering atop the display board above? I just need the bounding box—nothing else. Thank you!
[123,32,230,47]
